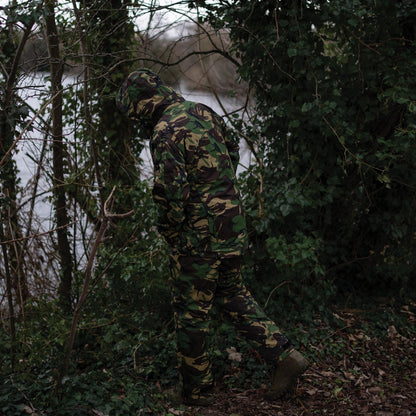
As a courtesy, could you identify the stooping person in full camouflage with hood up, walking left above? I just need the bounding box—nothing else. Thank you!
[116,69,308,405]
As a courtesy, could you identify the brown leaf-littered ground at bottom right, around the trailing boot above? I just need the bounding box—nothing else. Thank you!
[159,304,416,416]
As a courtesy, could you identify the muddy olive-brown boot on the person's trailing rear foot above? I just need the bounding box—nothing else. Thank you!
[266,350,309,400]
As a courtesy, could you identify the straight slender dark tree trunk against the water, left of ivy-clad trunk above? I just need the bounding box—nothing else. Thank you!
[45,0,73,312]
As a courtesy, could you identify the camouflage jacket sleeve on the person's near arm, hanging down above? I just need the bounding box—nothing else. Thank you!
[152,133,189,243]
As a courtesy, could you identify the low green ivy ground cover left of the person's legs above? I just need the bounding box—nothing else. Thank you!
[0,299,177,416]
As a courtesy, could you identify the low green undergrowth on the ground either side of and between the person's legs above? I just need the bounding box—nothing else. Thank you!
[0,290,416,416]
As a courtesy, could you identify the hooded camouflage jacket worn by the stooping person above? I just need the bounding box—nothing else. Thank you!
[116,70,247,257]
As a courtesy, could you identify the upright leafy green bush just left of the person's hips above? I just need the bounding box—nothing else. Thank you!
[89,181,171,321]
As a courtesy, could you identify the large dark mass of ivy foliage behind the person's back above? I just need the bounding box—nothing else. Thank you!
[194,0,416,300]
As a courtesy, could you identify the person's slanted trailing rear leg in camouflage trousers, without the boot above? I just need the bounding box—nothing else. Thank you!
[216,257,292,362]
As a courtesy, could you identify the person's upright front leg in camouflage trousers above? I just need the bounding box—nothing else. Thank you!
[171,255,218,398]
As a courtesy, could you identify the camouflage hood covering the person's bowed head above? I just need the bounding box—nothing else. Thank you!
[116,69,185,126]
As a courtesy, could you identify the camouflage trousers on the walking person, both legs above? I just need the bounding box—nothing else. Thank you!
[170,254,291,397]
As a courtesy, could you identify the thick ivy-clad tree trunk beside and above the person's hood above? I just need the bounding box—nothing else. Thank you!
[84,0,138,190]
